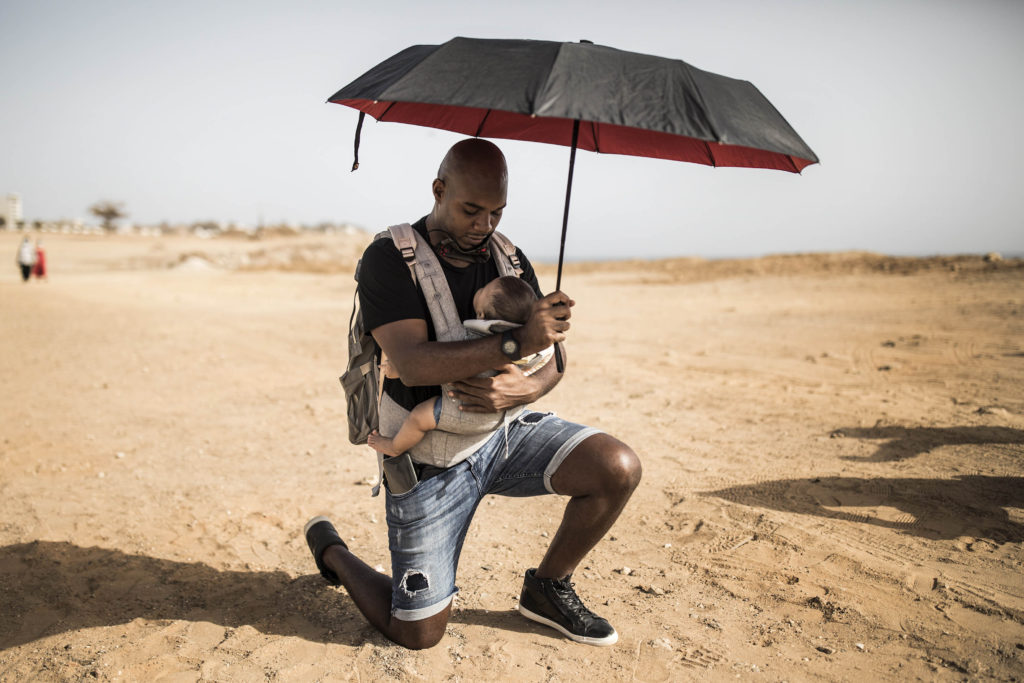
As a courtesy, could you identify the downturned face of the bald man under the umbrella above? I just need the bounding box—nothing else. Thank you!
[433,172,507,250]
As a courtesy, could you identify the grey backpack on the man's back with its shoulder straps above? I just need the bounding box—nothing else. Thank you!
[339,223,522,444]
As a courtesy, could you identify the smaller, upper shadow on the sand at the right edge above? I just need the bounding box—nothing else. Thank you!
[831,426,1024,463]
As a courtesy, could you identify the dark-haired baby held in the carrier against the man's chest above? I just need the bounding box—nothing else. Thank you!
[367,275,554,456]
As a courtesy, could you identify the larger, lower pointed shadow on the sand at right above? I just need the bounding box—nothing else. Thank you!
[701,475,1024,544]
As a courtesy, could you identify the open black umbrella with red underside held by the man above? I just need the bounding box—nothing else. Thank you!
[328,38,818,366]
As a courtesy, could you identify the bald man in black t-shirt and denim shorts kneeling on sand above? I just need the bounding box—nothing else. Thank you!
[305,138,641,648]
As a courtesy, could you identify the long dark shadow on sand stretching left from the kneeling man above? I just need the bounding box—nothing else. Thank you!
[0,541,529,650]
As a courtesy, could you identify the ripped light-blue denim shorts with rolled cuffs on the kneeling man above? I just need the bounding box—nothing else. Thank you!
[385,411,599,622]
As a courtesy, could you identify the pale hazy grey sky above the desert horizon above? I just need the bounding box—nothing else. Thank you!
[0,0,1024,261]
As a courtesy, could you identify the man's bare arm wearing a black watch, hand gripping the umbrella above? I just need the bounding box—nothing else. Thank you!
[372,292,574,395]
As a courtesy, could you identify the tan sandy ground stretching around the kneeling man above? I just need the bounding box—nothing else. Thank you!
[0,233,1024,681]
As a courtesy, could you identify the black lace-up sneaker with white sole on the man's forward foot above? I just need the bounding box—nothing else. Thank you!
[519,569,618,645]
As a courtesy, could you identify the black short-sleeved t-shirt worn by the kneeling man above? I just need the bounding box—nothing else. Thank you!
[359,216,541,410]
